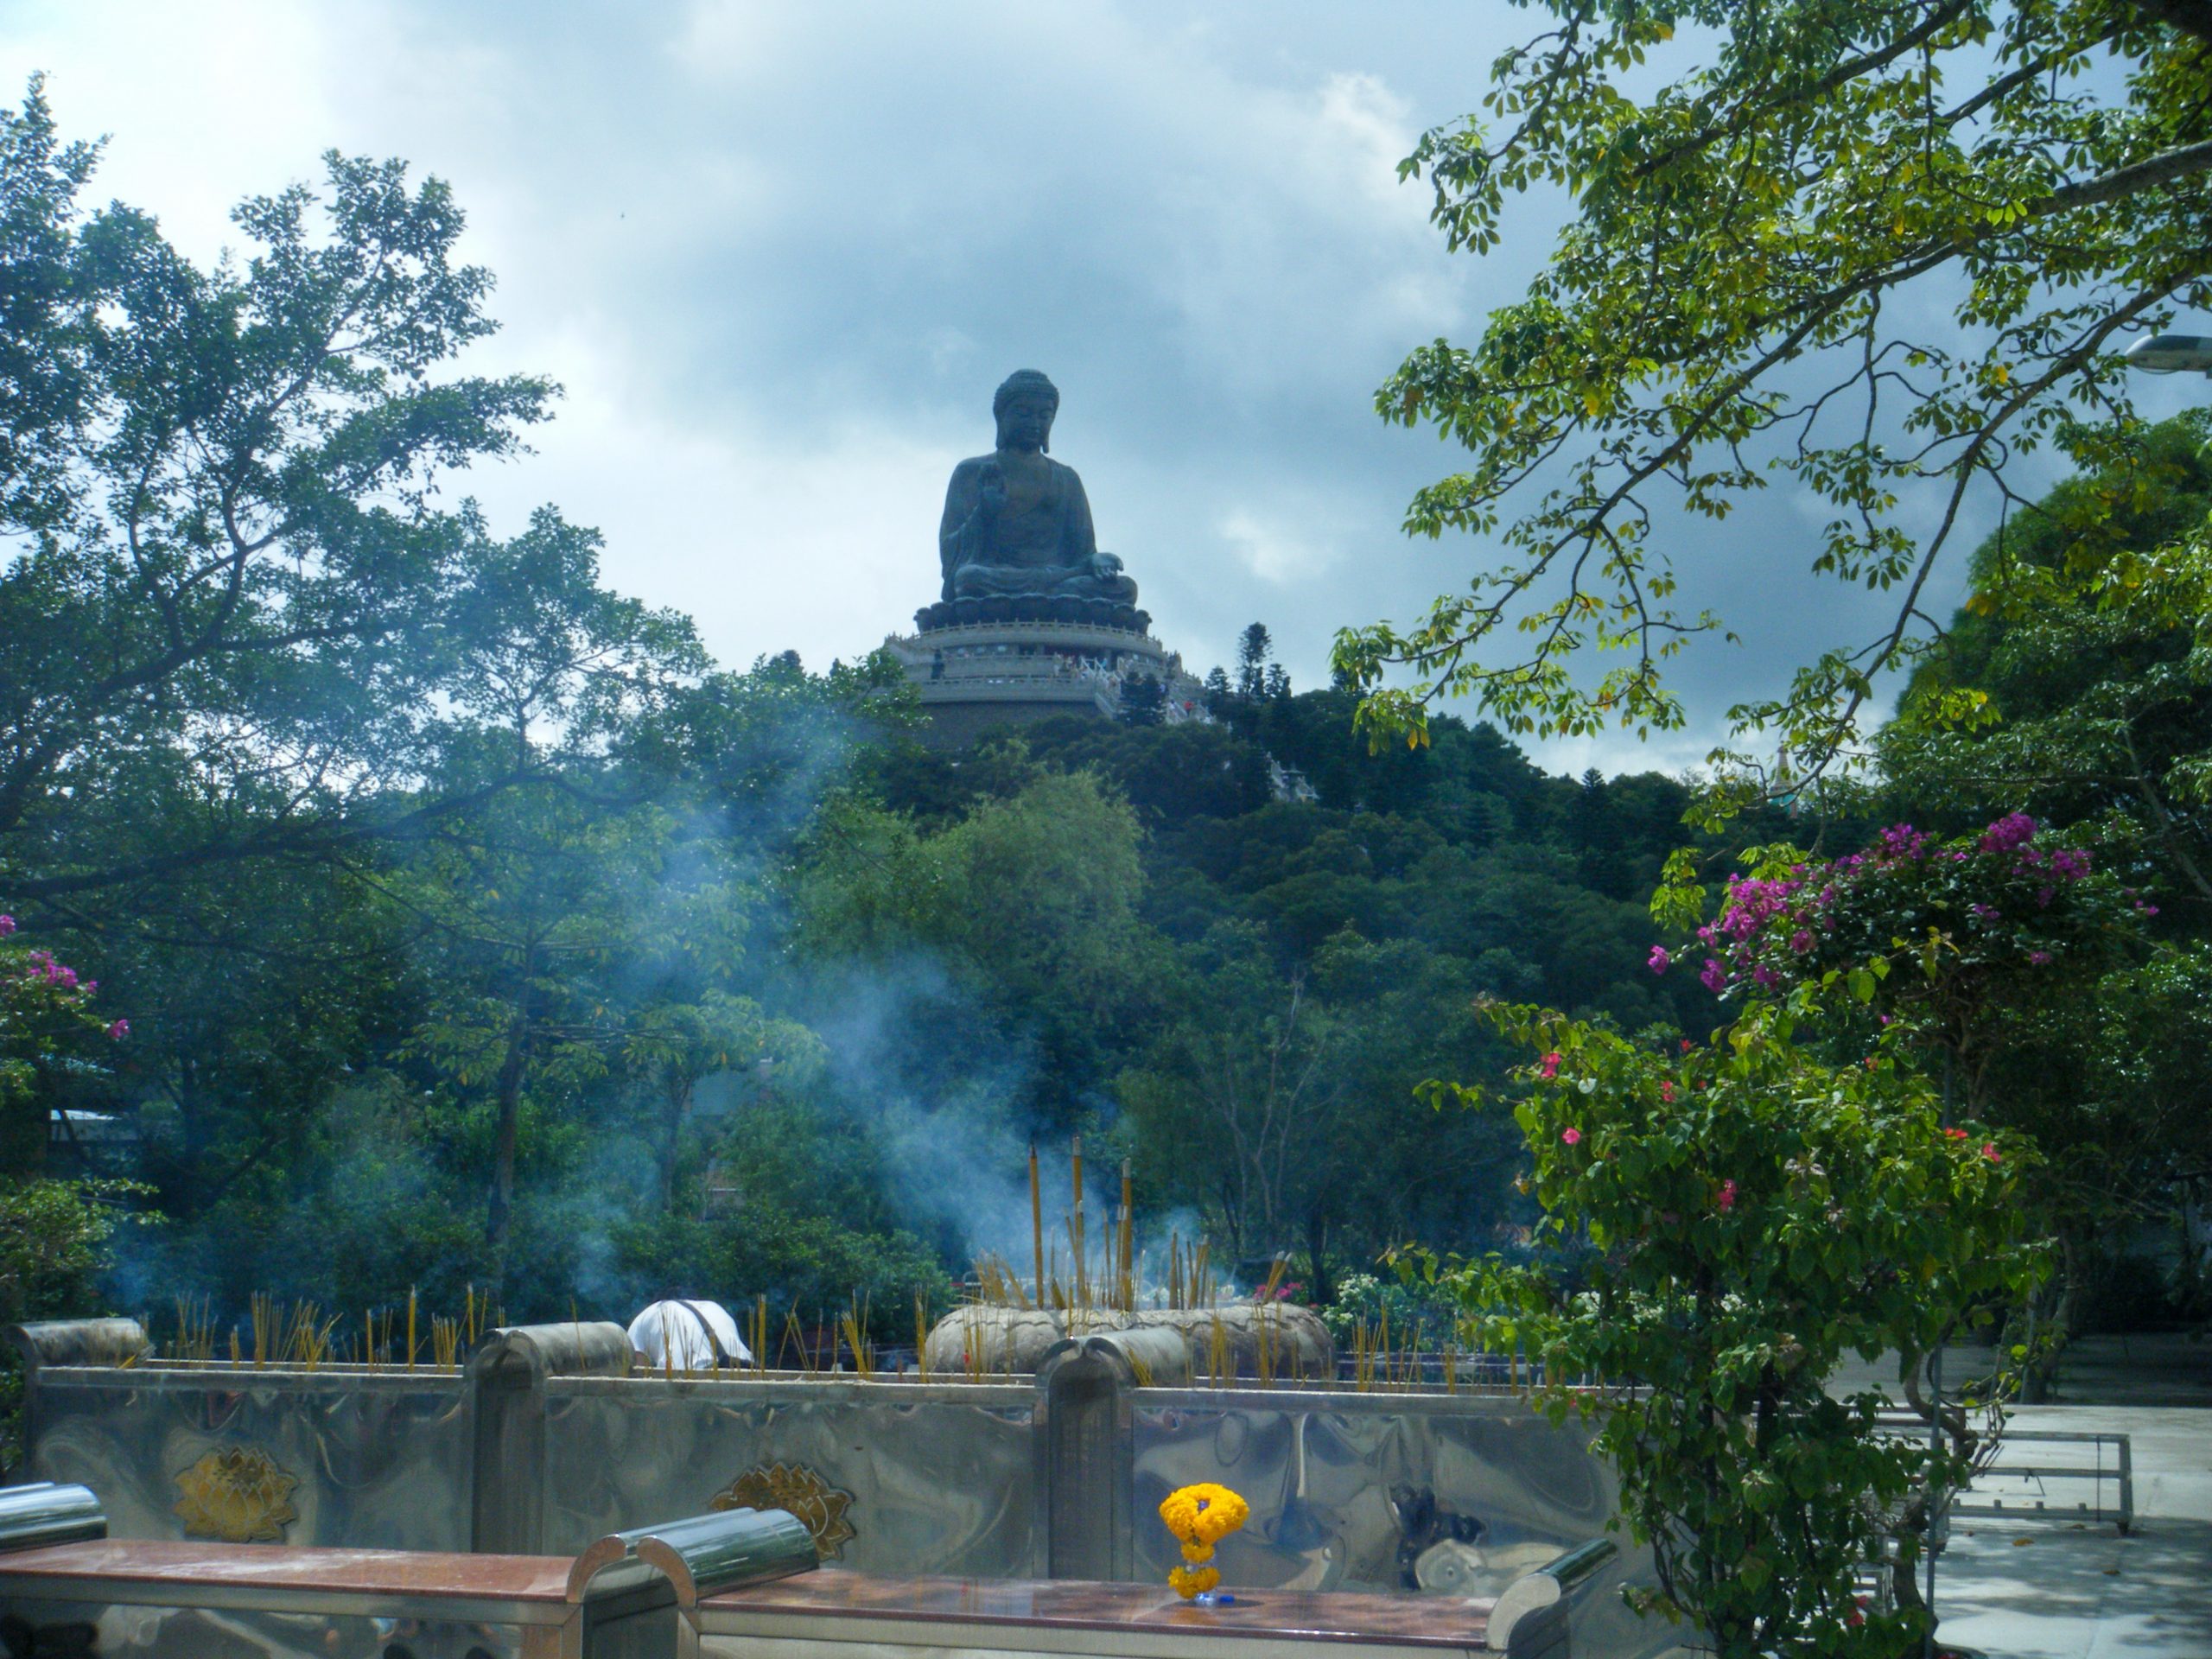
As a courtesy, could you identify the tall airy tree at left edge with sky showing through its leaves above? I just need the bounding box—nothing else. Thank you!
[0,86,550,900]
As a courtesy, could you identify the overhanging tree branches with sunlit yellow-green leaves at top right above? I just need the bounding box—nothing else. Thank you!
[1336,0,2212,801]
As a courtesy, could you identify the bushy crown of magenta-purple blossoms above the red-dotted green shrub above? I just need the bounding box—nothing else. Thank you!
[1652,812,2157,1046]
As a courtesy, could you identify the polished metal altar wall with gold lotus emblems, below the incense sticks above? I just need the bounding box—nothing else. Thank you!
[16,1325,1648,1595]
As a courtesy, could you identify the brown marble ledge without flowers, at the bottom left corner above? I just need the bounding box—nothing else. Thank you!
[0,1537,569,1601]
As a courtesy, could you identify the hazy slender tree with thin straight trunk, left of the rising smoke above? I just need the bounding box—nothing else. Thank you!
[396,511,706,1259]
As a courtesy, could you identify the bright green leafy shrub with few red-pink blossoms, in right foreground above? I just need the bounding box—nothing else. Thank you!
[1429,991,2042,1659]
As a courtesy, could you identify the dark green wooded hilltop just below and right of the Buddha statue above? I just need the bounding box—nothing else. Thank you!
[874,692,1710,1028]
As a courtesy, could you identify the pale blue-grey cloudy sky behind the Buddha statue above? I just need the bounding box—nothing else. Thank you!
[0,0,2183,770]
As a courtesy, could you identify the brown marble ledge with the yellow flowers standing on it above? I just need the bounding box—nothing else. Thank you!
[699,1566,1493,1650]
